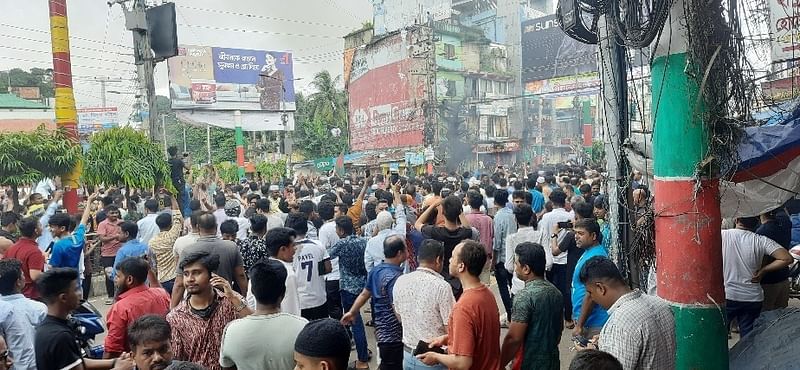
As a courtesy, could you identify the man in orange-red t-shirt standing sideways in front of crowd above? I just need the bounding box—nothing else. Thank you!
[417,240,500,370]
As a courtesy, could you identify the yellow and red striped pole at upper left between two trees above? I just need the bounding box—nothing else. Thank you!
[48,0,81,213]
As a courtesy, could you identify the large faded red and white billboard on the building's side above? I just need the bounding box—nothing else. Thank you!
[347,29,429,151]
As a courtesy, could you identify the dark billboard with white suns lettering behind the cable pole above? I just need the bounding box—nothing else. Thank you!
[522,15,598,81]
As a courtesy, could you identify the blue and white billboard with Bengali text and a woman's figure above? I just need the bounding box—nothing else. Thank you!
[167,45,295,111]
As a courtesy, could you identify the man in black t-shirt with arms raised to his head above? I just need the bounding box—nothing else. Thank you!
[414,195,478,300]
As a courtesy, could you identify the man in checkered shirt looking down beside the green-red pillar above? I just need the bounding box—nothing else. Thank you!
[580,256,675,370]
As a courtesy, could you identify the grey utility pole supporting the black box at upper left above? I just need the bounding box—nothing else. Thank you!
[114,0,161,142]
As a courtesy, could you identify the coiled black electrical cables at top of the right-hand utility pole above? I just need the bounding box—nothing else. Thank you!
[556,0,672,49]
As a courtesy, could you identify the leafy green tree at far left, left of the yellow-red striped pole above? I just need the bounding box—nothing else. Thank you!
[0,125,81,208]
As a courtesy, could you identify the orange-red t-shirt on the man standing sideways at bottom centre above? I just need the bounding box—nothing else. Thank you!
[447,285,500,370]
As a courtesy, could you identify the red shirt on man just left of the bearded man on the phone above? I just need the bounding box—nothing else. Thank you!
[105,285,170,353]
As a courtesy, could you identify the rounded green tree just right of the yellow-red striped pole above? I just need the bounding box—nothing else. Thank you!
[83,127,174,191]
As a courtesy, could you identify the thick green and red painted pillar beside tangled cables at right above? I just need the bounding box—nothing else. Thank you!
[651,0,728,369]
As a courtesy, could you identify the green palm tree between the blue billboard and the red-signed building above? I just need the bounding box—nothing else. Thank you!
[294,71,349,158]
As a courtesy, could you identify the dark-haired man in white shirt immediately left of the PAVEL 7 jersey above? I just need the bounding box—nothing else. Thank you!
[247,227,300,316]
